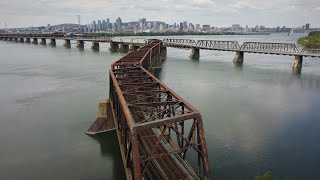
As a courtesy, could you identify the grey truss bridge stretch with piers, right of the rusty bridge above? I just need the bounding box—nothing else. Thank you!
[163,39,320,68]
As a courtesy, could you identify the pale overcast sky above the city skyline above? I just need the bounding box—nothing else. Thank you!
[0,0,320,28]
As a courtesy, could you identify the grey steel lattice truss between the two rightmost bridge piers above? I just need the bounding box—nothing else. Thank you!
[241,42,299,53]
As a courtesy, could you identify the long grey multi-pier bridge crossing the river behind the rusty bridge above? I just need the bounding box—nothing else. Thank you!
[0,33,320,69]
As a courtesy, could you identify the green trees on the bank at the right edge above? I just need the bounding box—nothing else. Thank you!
[298,31,320,49]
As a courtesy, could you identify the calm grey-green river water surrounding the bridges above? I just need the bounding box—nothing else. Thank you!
[0,35,320,179]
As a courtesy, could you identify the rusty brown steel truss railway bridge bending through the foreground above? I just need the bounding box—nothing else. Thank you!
[109,40,211,180]
